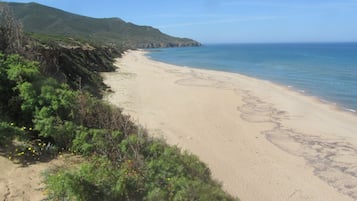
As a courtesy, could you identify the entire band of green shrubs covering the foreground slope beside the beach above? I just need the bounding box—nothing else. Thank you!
[0,48,235,201]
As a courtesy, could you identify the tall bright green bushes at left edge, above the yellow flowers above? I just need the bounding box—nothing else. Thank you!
[0,54,78,147]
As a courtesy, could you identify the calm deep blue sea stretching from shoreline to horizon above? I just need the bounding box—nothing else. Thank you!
[148,43,357,112]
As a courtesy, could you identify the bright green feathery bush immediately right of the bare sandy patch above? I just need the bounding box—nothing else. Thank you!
[46,157,143,201]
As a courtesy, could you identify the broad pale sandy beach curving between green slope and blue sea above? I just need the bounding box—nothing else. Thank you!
[103,51,357,201]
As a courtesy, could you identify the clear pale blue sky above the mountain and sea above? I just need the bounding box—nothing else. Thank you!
[6,0,357,43]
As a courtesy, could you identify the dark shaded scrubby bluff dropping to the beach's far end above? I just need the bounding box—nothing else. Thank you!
[27,40,122,97]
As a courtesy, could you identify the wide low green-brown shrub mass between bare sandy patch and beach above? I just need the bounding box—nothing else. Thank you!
[46,137,235,201]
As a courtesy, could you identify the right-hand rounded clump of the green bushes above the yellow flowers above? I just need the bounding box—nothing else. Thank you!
[32,79,77,148]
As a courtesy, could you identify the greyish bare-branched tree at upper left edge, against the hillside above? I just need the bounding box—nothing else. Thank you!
[0,1,23,53]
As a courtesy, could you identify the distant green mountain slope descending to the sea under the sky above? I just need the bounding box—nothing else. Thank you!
[8,3,200,48]
